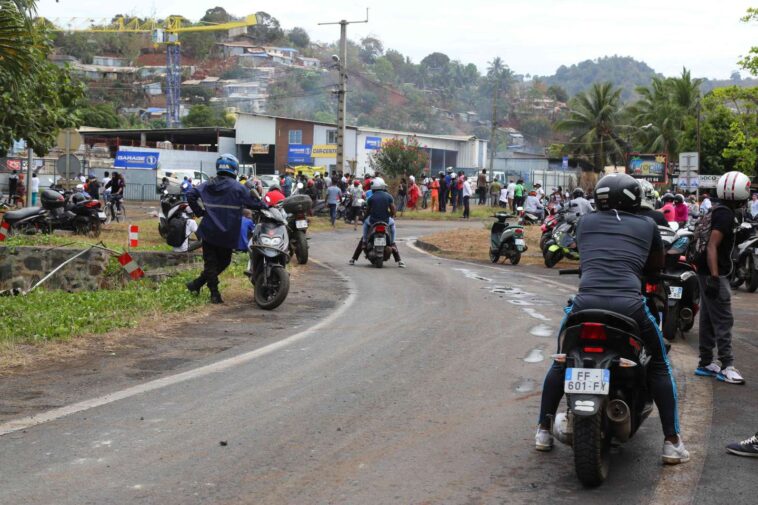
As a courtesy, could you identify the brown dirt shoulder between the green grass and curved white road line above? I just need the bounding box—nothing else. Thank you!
[0,262,346,421]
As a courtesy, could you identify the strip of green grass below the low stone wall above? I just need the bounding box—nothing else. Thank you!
[0,270,208,343]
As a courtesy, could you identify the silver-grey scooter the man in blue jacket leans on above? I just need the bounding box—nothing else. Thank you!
[245,207,290,310]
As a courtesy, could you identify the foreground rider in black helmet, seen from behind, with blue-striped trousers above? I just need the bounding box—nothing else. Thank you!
[535,174,689,464]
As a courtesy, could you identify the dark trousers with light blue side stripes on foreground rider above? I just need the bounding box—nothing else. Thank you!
[539,294,679,437]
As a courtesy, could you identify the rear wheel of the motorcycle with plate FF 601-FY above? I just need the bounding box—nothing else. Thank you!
[574,409,611,487]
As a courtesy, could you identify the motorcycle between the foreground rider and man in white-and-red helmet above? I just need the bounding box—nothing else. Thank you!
[658,222,700,340]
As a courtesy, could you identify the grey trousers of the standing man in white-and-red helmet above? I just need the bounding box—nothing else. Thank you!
[697,275,734,368]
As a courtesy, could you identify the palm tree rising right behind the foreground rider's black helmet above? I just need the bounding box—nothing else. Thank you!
[557,82,624,186]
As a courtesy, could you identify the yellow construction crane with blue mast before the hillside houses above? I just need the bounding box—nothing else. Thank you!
[48,14,258,128]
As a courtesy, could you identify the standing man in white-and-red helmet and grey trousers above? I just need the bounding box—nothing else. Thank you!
[695,172,750,384]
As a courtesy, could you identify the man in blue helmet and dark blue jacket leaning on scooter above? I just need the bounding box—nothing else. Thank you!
[187,154,266,303]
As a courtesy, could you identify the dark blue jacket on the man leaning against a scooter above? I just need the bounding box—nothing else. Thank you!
[187,176,266,249]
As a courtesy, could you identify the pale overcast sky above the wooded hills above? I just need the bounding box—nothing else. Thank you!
[39,0,758,79]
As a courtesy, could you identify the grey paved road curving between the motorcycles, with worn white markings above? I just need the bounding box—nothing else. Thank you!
[0,224,758,504]
